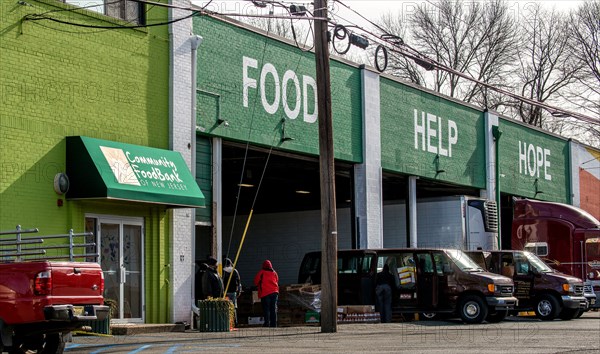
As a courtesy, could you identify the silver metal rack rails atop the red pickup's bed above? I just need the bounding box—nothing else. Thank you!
[0,225,100,263]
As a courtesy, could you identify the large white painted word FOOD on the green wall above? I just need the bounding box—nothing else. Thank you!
[242,56,317,123]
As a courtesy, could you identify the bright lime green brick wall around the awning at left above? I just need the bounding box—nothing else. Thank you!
[0,0,169,322]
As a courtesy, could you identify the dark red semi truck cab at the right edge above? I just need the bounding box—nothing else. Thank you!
[511,199,600,308]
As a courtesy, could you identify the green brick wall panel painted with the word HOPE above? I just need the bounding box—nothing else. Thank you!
[499,119,570,203]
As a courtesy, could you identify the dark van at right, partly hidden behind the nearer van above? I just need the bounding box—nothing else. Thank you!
[466,250,587,321]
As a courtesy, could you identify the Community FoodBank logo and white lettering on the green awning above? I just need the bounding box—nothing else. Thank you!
[99,146,188,190]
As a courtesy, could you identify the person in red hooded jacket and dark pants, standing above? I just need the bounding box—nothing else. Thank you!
[254,260,279,327]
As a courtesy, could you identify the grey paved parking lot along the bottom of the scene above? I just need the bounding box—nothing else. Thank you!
[65,312,600,354]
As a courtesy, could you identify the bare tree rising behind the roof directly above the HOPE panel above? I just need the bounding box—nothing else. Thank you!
[513,4,581,129]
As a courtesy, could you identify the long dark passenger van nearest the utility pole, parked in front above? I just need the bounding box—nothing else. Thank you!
[298,249,517,323]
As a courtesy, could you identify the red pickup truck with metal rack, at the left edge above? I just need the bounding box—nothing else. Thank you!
[0,228,109,353]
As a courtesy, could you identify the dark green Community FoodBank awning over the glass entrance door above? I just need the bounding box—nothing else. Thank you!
[67,136,204,208]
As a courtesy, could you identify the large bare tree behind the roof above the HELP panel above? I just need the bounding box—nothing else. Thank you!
[381,0,516,109]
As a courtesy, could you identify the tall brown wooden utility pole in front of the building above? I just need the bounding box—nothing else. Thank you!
[314,0,337,333]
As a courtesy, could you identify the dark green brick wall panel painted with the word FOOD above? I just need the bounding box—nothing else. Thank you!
[194,16,362,162]
